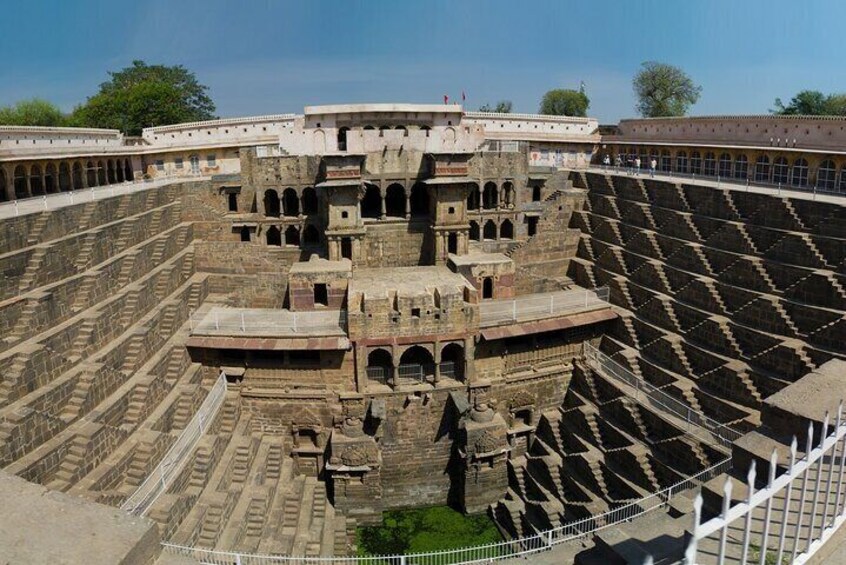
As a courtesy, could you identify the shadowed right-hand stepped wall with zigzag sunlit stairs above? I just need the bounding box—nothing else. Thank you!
[570,173,846,426]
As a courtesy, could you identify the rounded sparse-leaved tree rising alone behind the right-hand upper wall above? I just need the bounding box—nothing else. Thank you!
[632,61,702,118]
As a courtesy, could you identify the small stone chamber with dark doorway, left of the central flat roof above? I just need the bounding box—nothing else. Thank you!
[288,255,352,311]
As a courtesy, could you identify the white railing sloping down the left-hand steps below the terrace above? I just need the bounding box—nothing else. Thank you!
[121,373,226,516]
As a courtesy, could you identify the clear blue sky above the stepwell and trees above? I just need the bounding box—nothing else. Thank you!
[0,0,846,122]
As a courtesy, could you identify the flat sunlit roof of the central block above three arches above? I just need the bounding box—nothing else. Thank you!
[349,267,473,299]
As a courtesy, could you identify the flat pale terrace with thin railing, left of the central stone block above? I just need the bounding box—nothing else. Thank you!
[189,307,347,336]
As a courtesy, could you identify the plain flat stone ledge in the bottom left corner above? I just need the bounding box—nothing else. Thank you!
[0,472,159,565]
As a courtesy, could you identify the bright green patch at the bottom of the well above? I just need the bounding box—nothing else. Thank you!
[356,506,502,557]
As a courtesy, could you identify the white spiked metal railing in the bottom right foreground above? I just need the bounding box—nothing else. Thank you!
[685,402,846,565]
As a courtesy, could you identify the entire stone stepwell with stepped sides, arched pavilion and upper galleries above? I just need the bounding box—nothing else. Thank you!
[0,104,846,564]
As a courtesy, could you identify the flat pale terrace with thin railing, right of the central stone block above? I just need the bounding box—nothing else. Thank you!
[479,287,609,328]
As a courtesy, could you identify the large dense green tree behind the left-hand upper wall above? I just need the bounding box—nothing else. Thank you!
[71,61,215,135]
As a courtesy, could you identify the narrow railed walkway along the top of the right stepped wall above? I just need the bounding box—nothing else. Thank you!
[587,165,846,205]
